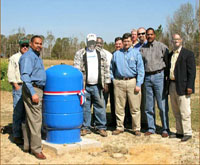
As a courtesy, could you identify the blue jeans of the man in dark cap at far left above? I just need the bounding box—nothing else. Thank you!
[12,86,25,137]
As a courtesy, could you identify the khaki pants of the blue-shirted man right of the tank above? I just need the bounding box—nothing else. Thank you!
[114,78,141,131]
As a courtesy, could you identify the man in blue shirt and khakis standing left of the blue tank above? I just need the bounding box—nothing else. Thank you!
[19,36,46,159]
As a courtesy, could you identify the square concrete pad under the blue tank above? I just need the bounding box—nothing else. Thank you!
[42,138,101,155]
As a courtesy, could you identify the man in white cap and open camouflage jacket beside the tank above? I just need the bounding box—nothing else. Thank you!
[74,33,110,137]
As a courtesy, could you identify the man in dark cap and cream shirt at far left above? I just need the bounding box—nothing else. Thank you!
[7,37,29,144]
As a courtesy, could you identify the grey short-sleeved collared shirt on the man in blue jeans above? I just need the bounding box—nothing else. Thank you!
[140,40,169,72]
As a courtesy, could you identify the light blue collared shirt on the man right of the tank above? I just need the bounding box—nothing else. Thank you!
[110,47,144,87]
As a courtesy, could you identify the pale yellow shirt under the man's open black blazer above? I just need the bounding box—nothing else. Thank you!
[170,46,182,80]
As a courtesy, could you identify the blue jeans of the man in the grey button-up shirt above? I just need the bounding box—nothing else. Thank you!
[145,71,169,133]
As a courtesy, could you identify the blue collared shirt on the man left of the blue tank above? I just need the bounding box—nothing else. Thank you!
[19,48,46,95]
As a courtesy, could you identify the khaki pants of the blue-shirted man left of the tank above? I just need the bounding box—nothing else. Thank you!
[22,85,43,153]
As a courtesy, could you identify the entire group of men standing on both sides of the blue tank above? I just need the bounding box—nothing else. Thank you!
[8,27,196,159]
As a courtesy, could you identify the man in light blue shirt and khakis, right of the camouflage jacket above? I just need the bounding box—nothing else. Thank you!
[110,33,144,136]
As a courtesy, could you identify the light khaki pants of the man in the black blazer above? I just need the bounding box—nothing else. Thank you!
[169,82,192,135]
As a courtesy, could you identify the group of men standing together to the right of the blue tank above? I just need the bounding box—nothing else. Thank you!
[74,27,196,141]
